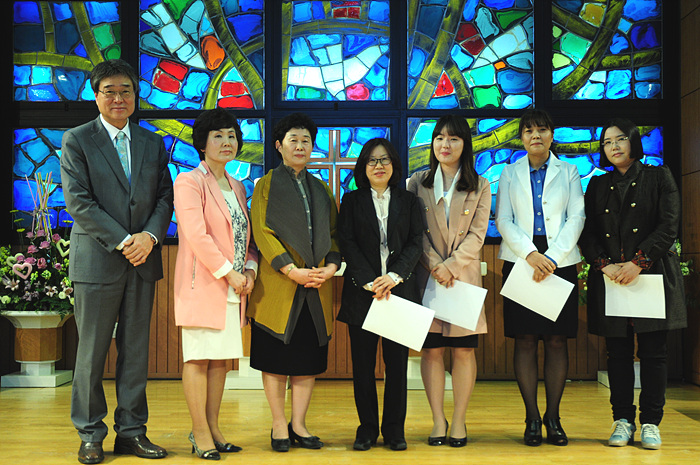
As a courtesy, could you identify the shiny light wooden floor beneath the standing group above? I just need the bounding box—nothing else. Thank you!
[0,380,700,465]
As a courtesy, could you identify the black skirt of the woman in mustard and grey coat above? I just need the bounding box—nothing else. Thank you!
[250,303,328,376]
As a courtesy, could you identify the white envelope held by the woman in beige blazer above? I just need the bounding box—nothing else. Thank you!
[423,277,488,331]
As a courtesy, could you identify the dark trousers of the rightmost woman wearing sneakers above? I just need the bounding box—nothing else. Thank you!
[605,326,668,425]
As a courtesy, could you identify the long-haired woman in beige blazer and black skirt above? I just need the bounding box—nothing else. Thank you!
[408,115,491,447]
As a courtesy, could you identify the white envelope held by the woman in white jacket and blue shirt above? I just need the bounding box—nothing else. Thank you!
[501,258,574,321]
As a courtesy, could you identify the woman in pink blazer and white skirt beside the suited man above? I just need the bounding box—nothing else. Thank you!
[175,109,258,460]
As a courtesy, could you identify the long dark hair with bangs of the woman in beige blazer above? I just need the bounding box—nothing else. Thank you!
[423,115,479,192]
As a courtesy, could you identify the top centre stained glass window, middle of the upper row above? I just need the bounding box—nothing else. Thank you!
[281,0,390,101]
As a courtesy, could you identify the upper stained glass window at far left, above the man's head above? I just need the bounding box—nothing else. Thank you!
[13,1,121,102]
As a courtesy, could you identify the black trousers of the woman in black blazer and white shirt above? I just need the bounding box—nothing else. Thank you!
[348,325,408,441]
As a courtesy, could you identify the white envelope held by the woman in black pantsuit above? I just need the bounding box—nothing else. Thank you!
[362,295,435,351]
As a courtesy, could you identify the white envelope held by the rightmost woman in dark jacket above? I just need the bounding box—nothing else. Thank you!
[603,274,666,319]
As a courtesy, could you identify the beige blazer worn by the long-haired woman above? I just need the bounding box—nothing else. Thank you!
[408,171,491,337]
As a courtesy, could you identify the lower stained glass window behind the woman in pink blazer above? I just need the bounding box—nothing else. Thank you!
[140,119,264,236]
